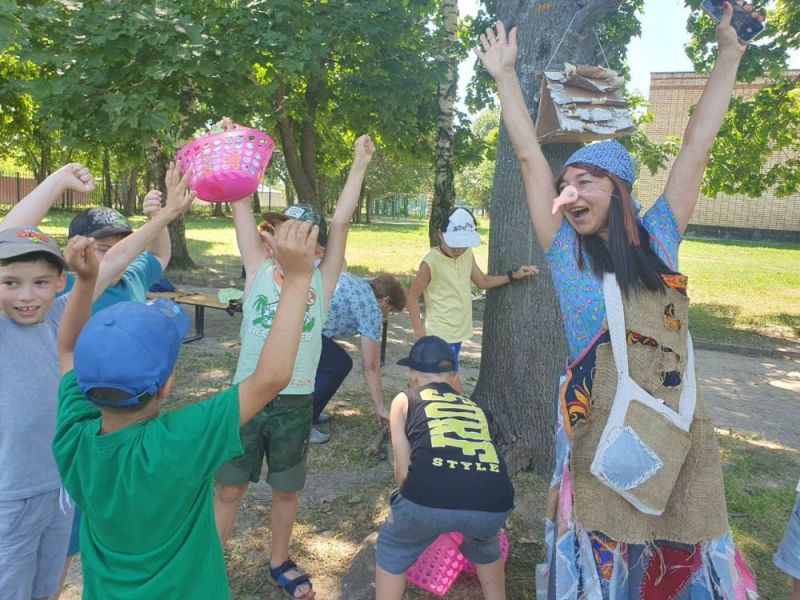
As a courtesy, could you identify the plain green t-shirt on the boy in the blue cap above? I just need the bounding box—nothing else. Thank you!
[53,372,242,600]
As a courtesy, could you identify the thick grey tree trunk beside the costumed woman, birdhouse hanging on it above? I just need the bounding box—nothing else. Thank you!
[474,0,621,475]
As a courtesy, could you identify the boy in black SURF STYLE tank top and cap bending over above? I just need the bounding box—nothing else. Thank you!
[375,336,514,600]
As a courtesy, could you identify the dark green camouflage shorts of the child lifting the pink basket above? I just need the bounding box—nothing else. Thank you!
[217,394,313,492]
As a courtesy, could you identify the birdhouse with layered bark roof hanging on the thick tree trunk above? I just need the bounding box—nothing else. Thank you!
[536,63,633,144]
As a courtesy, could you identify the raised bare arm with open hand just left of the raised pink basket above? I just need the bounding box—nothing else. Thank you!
[94,163,196,300]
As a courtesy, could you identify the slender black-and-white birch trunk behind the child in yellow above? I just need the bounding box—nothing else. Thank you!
[428,0,458,246]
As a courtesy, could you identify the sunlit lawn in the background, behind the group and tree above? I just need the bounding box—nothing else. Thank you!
[29,212,800,347]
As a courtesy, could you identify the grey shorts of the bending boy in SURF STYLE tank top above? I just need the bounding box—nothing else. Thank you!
[377,494,511,575]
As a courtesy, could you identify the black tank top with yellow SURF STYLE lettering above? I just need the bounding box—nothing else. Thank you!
[400,383,514,512]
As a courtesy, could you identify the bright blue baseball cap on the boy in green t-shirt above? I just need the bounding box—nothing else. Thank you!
[75,298,191,408]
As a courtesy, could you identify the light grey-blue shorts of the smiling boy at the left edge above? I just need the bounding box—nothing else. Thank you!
[0,490,72,600]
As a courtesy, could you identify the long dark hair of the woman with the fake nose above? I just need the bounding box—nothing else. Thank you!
[556,163,675,295]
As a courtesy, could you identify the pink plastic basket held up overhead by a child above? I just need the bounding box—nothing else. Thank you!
[175,125,275,202]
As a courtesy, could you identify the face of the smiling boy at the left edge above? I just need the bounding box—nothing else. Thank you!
[0,258,66,325]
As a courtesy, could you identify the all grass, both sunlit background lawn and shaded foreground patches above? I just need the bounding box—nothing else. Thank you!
[4,206,800,600]
